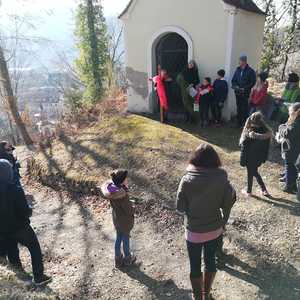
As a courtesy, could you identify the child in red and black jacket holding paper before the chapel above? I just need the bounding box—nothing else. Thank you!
[196,77,213,128]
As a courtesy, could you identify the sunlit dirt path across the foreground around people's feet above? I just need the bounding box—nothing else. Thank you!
[0,178,300,300]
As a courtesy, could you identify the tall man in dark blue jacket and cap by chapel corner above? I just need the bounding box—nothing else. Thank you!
[231,55,256,127]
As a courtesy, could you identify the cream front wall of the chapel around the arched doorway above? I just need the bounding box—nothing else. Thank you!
[122,0,227,111]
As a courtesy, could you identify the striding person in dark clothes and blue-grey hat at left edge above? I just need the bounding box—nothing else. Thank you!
[0,159,51,285]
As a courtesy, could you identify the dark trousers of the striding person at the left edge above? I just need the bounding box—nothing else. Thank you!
[6,225,44,279]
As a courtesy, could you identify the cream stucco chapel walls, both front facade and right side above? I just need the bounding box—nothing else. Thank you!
[122,0,264,119]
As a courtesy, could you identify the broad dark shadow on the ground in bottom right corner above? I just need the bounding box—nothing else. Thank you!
[223,239,300,300]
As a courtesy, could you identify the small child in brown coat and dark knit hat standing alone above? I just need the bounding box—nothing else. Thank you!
[101,170,136,268]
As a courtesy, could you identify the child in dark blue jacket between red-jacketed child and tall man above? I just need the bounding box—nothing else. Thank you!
[211,70,228,126]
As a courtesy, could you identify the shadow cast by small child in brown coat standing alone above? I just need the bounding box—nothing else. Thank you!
[122,266,191,300]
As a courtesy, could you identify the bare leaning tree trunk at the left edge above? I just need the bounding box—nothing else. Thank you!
[0,46,33,146]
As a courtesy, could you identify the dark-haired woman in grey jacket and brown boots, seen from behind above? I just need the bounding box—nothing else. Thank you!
[177,144,236,300]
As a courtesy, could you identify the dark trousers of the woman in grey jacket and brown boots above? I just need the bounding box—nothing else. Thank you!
[187,237,221,278]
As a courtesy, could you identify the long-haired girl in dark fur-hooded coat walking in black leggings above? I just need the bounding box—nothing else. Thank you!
[240,112,273,197]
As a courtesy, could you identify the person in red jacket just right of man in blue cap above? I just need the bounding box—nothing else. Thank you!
[249,72,269,115]
